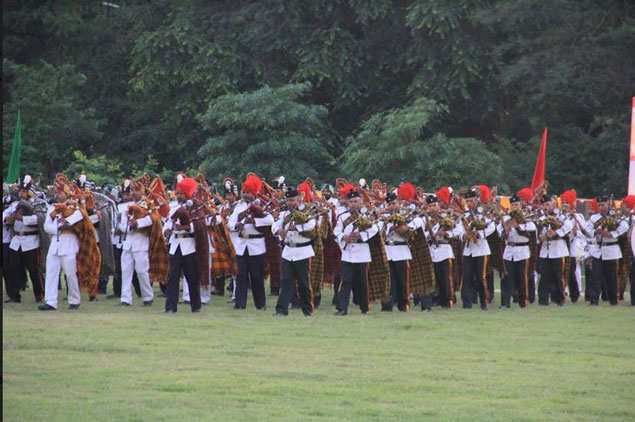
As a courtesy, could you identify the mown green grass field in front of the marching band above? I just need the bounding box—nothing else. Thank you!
[2,284,635,421]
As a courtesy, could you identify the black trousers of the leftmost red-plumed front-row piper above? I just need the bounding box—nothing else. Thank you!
[165,246,201,312]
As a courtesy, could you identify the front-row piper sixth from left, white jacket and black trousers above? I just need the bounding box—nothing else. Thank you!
[271,189,316,316]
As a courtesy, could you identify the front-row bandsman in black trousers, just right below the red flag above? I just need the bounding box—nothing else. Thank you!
[538,195,573,306]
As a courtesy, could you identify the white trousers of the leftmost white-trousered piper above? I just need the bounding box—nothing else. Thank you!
[44,253,80,309]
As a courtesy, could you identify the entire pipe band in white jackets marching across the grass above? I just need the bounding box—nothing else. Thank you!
[2,173,635,317]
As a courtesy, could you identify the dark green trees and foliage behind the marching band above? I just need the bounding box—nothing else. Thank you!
[2,0,635,195]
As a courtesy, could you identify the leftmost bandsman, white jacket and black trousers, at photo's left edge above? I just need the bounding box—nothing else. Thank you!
[5,175,44,303]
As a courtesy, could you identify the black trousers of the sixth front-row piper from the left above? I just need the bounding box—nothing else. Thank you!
[276,258,313,315]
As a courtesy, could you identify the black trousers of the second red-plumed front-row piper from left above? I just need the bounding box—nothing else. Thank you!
[234,248,267,309]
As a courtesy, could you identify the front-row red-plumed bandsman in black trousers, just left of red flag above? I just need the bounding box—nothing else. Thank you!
[497,195,536,308]
